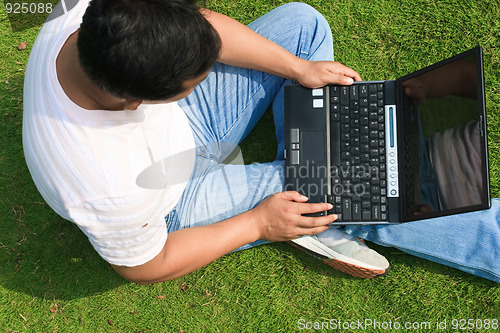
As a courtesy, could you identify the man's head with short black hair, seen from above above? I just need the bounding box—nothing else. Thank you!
[77,0,221,101]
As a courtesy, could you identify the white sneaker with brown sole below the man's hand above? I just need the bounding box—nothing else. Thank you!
[290,228,390,278]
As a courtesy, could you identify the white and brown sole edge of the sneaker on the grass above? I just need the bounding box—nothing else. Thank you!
[287,236,390,279]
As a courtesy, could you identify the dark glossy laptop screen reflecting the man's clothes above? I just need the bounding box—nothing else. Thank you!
[398,48,490,221]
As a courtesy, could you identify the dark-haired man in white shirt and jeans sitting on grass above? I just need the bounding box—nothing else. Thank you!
[23,0,496,283]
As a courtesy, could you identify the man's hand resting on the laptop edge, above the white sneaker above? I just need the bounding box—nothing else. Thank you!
[249,191,337,242]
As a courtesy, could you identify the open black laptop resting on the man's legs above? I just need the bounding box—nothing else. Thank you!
[285,47,491,225]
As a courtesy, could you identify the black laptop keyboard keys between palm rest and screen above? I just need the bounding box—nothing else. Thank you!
[327,83,387,222]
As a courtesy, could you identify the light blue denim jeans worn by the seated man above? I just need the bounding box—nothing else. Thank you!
[170,3,500,282]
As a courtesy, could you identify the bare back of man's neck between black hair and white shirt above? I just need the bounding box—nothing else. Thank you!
[56,31,129,111]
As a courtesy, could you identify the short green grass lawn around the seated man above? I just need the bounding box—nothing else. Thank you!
[0,0,500,332]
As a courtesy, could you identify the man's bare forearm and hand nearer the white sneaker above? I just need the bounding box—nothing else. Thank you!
[112,192,336,284]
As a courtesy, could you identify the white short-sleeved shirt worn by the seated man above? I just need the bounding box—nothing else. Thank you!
[23,1,195,266]
